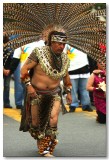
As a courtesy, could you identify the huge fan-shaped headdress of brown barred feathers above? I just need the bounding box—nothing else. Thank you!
[3,3,106,67]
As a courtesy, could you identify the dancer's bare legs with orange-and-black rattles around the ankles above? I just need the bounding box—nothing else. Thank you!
[29,97,60,157]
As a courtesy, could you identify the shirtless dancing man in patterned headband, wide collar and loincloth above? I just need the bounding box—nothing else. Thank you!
[20,31,72,156]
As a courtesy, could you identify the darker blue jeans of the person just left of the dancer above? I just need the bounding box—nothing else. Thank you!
[14,63,24,106]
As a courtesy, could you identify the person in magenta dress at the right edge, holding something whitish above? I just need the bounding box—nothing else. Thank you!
[86,63,106,123]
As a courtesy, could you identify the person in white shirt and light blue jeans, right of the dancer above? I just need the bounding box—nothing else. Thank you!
[64,44,93,112]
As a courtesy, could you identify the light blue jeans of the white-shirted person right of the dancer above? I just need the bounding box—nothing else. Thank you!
[71,78,90,109]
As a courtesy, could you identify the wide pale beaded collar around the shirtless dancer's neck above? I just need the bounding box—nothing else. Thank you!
[34,46,70,80]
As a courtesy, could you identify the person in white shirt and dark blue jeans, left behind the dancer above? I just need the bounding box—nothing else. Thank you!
[10,40,44,110]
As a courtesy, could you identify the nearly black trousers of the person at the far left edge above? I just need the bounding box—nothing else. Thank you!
[3,75,11,106]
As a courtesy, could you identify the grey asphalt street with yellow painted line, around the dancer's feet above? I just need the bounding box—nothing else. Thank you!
[3,82,107,158]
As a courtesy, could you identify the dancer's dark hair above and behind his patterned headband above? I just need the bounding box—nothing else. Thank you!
[48,31,67,46]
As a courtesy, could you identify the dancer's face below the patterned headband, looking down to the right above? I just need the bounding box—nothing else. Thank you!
[51,42,65,54]
